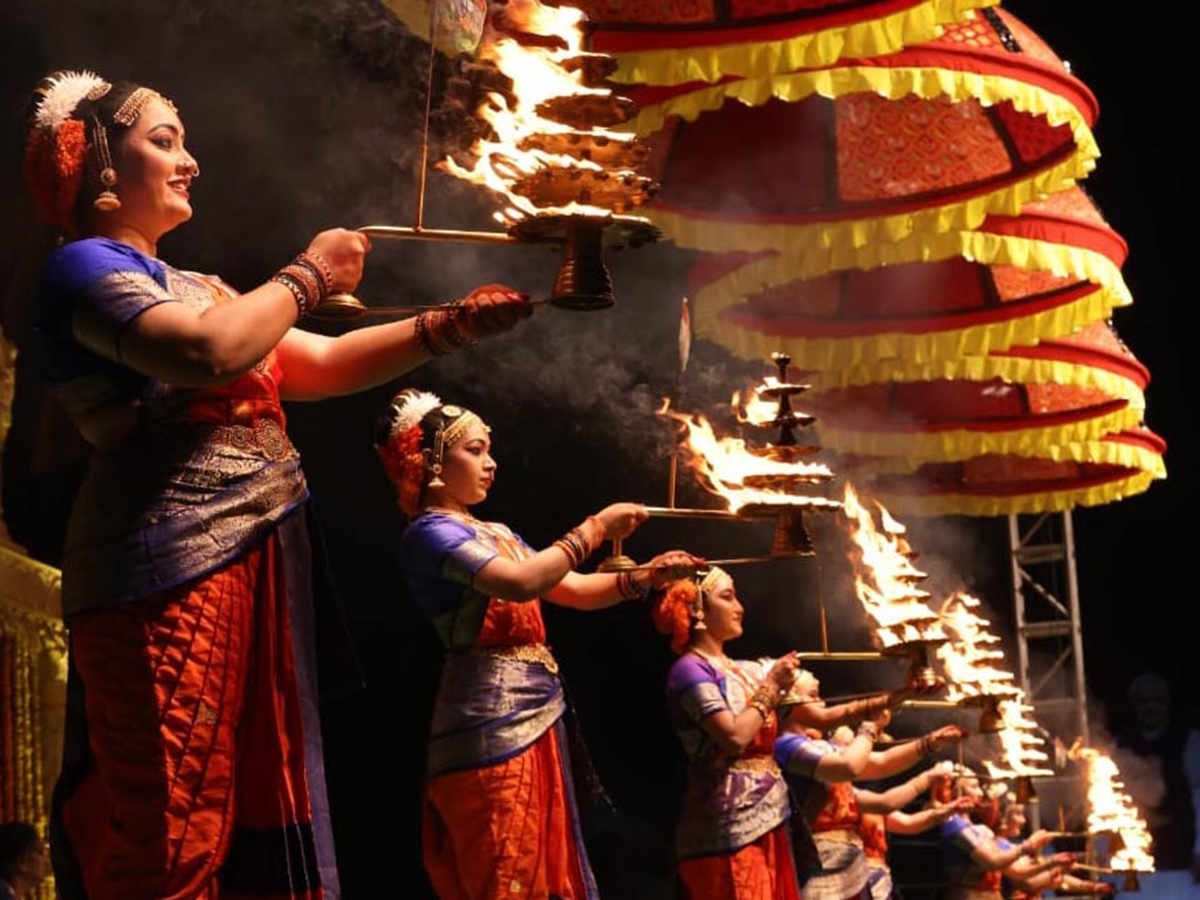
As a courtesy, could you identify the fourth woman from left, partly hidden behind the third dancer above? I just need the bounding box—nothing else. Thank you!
[775,671,965,900]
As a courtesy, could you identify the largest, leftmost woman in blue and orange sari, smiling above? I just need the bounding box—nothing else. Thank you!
[25,72,528,900]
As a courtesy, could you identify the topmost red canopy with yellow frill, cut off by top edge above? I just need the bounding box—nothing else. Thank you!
[582,0,997,84]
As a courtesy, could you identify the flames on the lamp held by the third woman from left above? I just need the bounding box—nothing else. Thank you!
[842,482,947,649]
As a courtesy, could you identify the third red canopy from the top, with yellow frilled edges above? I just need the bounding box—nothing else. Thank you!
[690,187,1132,374]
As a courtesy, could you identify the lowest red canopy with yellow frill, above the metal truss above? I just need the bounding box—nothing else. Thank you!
[857,428,1166,516]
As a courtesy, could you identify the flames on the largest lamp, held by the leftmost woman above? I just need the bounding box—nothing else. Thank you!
[440,0,635,226]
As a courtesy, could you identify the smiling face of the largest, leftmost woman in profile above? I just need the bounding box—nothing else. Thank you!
[106,97,198,240]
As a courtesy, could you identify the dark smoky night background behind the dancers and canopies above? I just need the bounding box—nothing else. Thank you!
[0,0,1200,900]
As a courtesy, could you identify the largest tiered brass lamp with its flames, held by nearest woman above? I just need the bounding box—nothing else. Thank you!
[422,0,659,310]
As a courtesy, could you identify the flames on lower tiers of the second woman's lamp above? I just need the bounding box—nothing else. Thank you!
[659,404,840,512]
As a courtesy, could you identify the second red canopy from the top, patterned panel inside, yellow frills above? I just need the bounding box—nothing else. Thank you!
[634,13,1099,260]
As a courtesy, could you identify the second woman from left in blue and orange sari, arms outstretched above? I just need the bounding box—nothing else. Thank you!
[376,391,696,900]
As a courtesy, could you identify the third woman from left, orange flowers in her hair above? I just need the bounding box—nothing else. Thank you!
[654,568,799,900]
